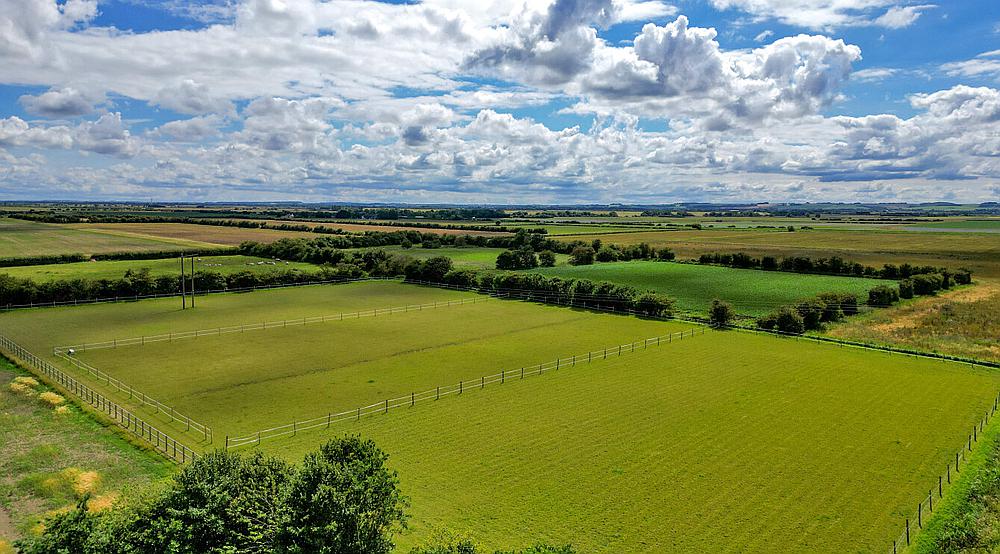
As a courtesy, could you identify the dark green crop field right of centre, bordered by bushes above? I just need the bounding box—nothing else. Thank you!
[532,261,891,315]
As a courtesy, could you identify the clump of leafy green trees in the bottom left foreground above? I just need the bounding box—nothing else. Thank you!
[15,436,573,554]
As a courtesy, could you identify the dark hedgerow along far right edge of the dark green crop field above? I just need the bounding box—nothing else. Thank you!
[698,252,972,284]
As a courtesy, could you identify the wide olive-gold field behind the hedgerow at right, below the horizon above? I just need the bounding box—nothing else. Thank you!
[566,224,1000,277]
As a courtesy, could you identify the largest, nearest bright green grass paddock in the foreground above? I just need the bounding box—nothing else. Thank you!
[261,332,1000,552]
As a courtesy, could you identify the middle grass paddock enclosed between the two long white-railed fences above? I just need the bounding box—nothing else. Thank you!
[62,292,689,435]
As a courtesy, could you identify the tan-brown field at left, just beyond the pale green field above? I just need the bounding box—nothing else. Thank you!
[68,223,320,246]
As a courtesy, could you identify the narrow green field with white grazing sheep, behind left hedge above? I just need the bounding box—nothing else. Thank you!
[0,256,317,282]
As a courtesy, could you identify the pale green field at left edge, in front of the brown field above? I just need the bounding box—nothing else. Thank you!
[0,218,211,258]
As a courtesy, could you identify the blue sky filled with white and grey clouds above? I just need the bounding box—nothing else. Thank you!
[0,0,1000,205]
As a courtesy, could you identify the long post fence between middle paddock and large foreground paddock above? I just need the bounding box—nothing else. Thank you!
[226,327,707,449]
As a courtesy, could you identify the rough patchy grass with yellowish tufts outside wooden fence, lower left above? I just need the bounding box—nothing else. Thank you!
[0,358,176,552]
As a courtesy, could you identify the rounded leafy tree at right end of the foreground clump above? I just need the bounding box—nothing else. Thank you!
[278,436,406,554]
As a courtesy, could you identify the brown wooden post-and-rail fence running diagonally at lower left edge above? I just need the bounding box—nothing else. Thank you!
[0,335,198,463]
